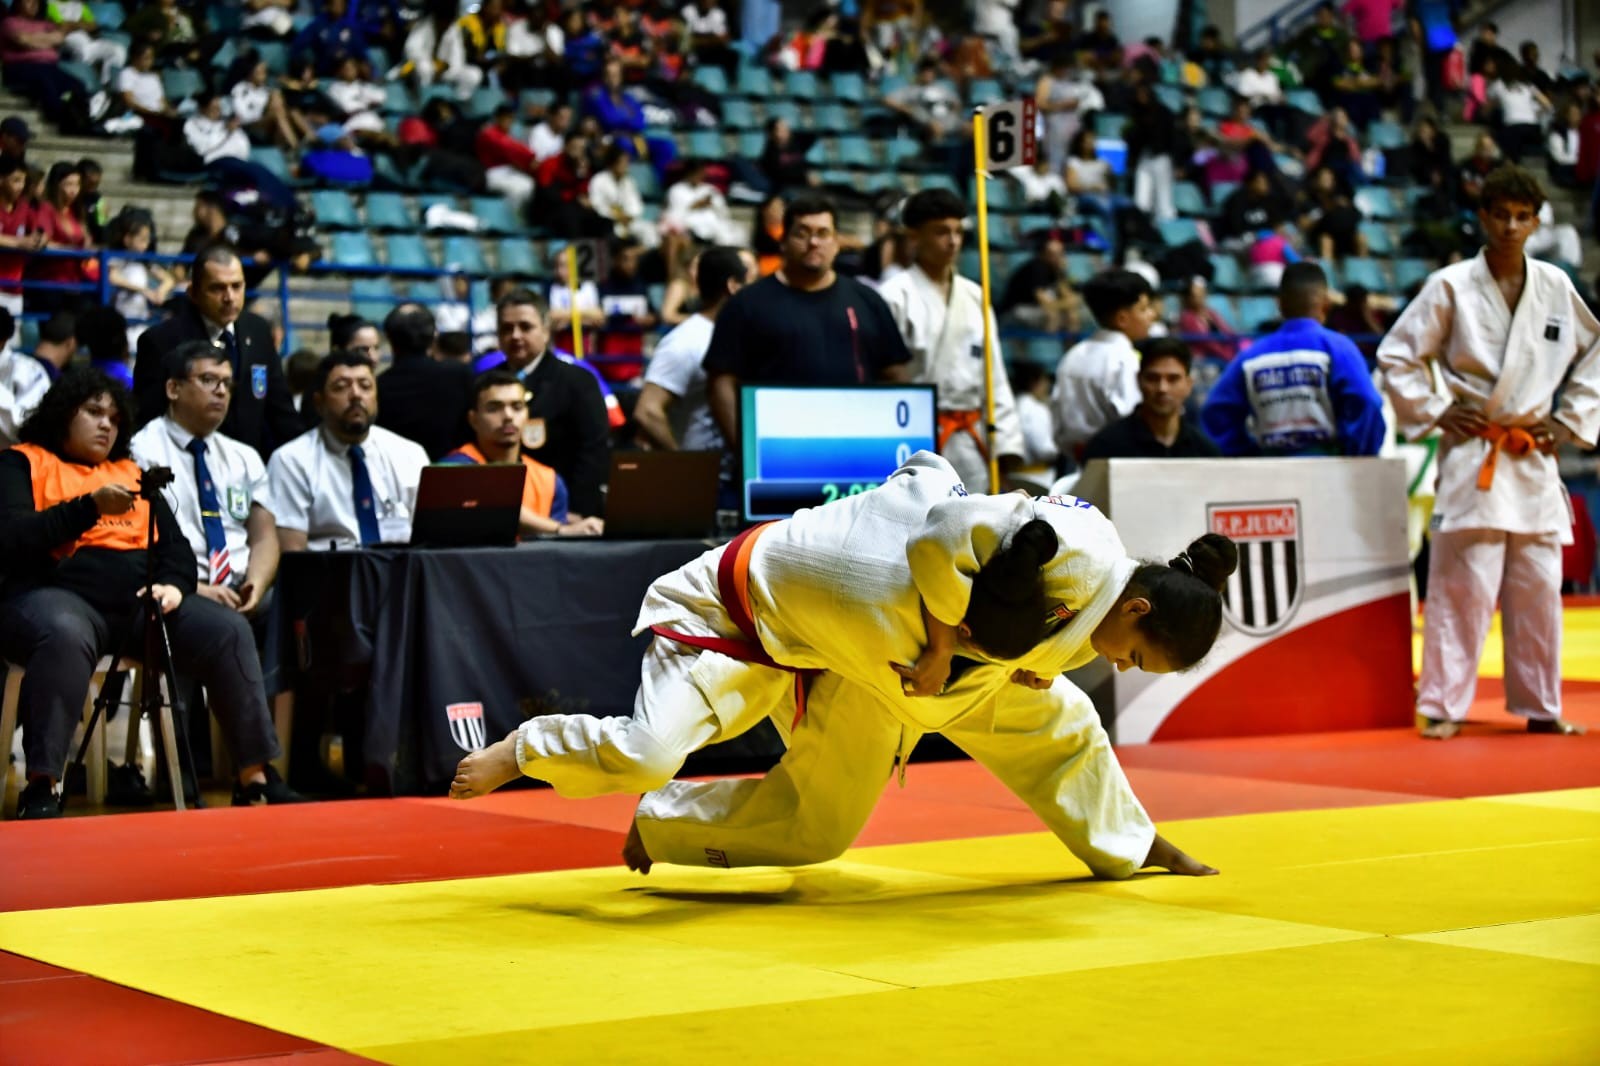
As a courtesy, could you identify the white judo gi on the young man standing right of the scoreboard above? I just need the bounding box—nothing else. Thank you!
[878,264,1024,493]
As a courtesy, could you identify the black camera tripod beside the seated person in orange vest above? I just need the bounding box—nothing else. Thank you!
[61,466,200,810]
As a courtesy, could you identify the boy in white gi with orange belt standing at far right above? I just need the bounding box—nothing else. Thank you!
[1378,166,1600,739]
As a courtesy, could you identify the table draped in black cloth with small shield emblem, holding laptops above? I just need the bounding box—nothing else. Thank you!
[277,539,709,794]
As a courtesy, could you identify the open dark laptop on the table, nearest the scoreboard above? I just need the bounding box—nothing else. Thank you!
[605,451,722,541]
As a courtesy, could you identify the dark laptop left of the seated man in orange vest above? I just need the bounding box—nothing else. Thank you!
[411,463,526,547]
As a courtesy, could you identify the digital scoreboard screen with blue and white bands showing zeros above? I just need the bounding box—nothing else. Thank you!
[739,384,938,522]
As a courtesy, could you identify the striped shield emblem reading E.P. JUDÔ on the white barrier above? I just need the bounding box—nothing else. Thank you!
[1206,499,1306,637]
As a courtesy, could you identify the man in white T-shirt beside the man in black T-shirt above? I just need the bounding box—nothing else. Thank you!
[634,246,755,464]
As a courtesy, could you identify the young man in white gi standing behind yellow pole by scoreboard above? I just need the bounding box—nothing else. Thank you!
[878,189,1024,491]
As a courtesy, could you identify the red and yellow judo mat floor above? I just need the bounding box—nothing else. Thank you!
[0,607,1600,1066]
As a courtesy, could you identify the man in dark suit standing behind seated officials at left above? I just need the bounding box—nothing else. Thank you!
[133,245,302,458]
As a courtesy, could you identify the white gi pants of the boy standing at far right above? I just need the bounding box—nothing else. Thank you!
[1416,530,1562,722]
